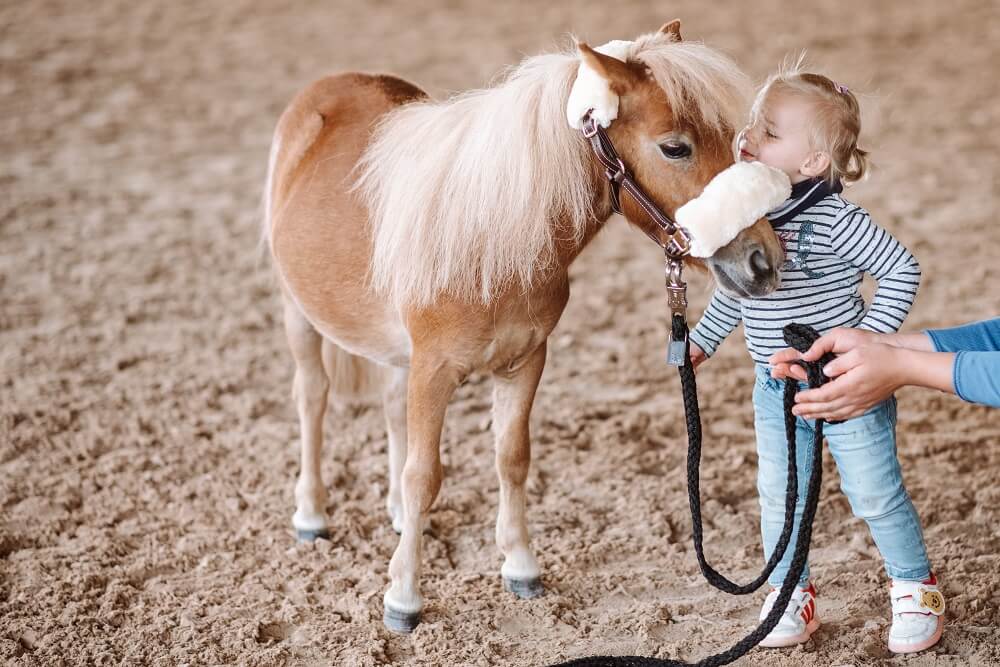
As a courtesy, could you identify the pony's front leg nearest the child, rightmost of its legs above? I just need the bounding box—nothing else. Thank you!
[493,343,545,598]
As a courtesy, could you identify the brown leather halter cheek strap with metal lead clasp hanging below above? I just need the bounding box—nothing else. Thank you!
[581,111,691,367]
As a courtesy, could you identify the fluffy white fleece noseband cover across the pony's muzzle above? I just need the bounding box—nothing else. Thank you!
[675,162,792,257]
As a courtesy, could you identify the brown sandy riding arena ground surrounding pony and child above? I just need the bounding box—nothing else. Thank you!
[0,0,1000,666]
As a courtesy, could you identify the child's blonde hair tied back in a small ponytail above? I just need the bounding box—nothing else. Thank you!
[741,56,869,185]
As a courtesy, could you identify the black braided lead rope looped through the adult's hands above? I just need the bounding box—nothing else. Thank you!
[553,324,833,667]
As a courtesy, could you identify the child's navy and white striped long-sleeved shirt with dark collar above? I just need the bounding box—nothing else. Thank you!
[691,180,920,364]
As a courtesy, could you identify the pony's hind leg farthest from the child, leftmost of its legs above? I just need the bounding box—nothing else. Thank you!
[285,298,330,542]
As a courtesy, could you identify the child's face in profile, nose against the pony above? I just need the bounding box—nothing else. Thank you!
[739,95,816,183]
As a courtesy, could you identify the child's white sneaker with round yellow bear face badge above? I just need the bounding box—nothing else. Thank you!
[889,574,944,653]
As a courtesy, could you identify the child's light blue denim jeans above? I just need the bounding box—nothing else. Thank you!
[753,365,930,586]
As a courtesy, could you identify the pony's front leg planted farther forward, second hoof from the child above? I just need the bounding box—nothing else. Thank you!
[382,351,461,632]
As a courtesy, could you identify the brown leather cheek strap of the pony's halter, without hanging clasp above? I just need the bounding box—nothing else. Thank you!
[583,112,691,258]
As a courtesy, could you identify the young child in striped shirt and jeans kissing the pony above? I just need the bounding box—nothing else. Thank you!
[691,65,944,653]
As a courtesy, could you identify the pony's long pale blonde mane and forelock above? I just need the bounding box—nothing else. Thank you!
[357,34,748,306]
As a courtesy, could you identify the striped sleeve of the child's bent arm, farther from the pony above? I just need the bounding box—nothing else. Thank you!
[830,208,920,333]
